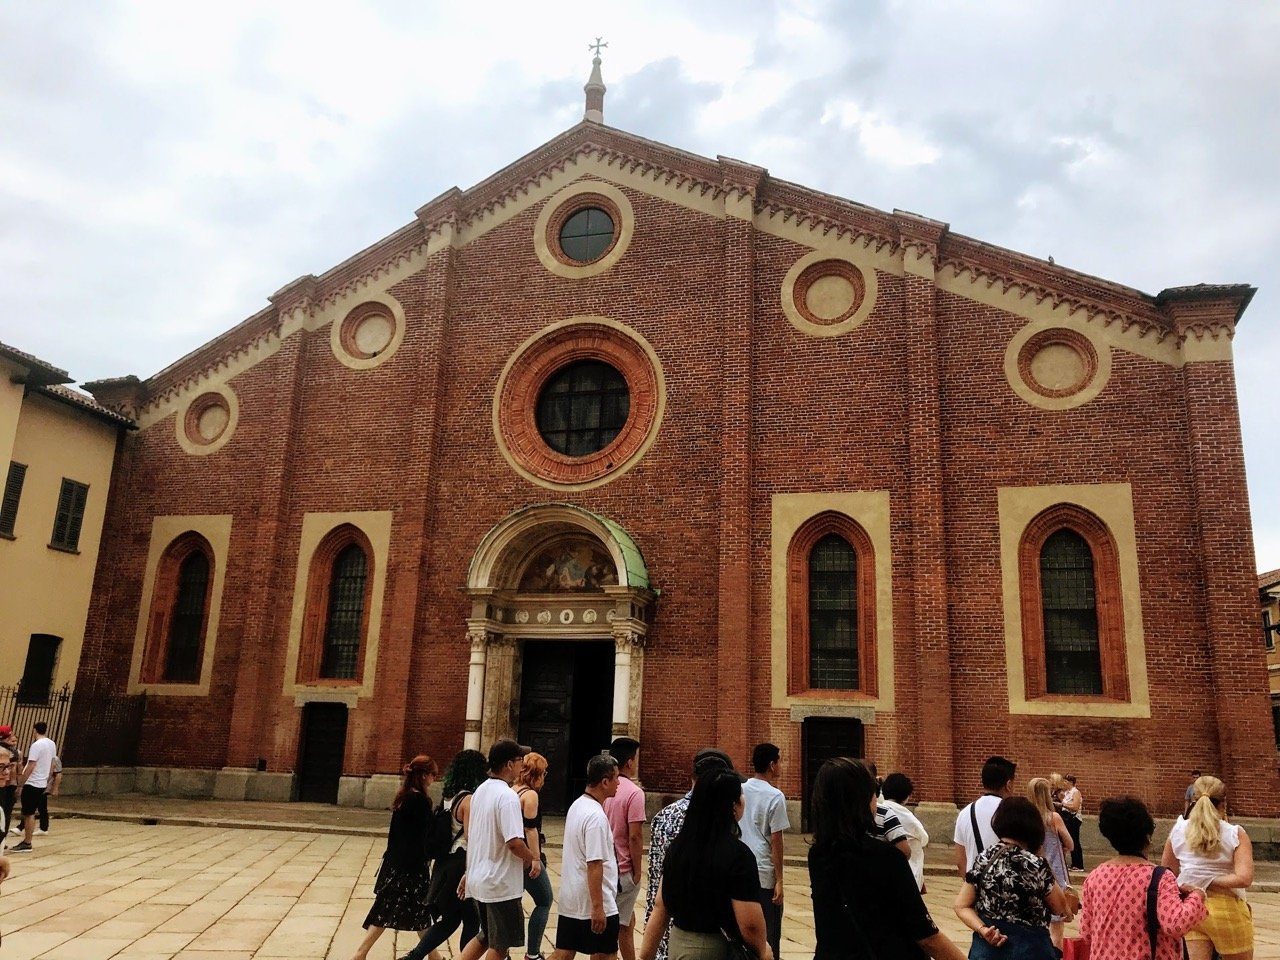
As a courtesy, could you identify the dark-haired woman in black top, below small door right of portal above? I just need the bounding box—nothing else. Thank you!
[809,756,964,960]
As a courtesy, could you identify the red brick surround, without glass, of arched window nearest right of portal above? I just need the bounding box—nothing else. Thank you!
[787,509,878,699]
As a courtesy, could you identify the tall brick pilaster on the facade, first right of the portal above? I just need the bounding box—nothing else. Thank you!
[716,157,768,765]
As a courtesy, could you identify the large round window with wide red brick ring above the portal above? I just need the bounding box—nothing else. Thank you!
[493,316,666,490]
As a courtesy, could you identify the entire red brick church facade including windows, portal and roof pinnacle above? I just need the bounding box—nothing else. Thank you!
[72,71,1277,814]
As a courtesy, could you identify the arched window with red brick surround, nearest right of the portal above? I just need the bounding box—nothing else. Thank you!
[787,512,876,696]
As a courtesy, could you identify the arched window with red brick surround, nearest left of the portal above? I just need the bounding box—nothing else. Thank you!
[298,524,374,684]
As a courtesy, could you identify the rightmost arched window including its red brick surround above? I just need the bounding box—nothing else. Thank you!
[1019,504,1129,700]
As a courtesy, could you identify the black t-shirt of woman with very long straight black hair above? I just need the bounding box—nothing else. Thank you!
[662,837,757,937]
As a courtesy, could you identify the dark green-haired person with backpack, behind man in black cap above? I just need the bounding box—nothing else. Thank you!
[401,750,489,960]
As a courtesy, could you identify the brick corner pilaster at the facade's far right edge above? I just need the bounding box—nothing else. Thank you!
[1167,287,1280,817]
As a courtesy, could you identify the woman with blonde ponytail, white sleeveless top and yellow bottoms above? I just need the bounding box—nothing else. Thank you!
[1162,777,1253,960]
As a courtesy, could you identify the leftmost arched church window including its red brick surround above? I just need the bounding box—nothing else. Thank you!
[142,532,214,684]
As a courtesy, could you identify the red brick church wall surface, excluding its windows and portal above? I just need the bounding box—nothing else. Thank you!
[72,123,1277,814]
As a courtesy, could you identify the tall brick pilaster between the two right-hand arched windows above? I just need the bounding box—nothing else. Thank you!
[893,210,960,801]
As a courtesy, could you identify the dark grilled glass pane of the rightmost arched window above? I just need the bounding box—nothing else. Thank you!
[1041,529,1102,695]
